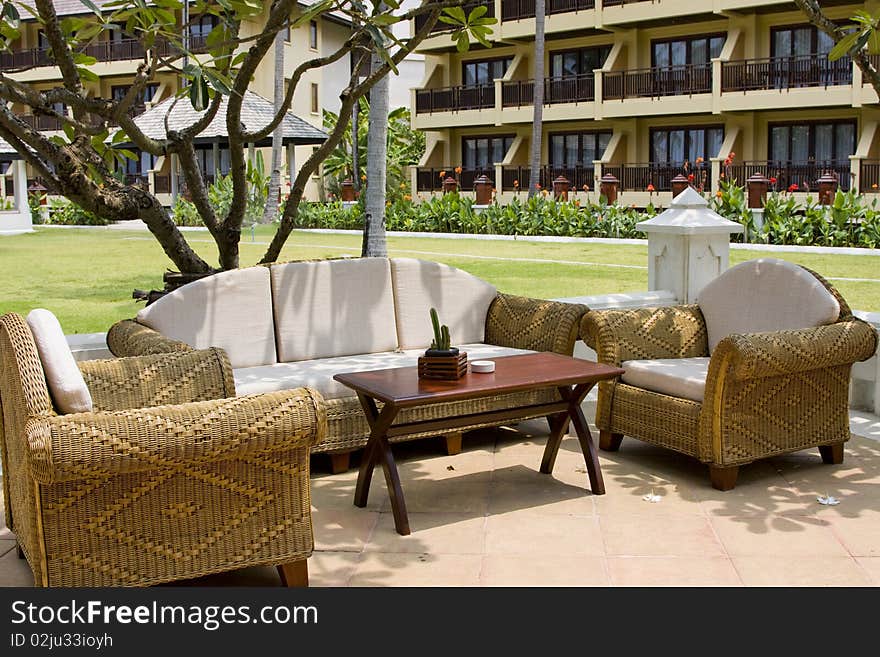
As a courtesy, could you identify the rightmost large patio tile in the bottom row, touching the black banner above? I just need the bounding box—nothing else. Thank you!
[733,555,871,586]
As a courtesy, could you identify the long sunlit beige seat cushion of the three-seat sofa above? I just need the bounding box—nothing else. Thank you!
[234,344,530,399]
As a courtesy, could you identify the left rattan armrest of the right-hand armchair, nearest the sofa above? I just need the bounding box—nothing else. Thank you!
[580,305,709,366]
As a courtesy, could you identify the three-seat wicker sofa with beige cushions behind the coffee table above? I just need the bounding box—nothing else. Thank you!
[107,258,587,472]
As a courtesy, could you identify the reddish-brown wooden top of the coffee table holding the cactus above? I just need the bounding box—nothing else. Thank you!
[333,352,624,406]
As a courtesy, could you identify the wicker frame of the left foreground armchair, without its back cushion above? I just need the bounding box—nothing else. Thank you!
[0,313,326,586]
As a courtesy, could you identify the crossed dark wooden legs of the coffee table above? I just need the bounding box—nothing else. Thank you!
[354,383,605,536]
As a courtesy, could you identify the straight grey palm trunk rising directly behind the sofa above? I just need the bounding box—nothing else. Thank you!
[361,46,388,258]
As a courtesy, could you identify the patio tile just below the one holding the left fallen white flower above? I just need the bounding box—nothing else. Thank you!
[599,513,724,557]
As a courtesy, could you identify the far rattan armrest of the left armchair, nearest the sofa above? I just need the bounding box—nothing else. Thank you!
[79,348,235,411]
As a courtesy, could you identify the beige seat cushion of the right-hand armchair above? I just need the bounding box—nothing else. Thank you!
[620,358,709,402]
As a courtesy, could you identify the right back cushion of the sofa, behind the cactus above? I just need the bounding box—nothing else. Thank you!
[391,258,497,349]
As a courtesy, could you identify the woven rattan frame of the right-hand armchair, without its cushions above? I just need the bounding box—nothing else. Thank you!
[581,261,877,490]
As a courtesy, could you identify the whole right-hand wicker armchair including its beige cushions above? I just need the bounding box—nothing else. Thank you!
[581,258,877,490]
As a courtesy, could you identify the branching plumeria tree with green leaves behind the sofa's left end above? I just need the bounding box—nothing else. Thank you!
[0,0,486,274]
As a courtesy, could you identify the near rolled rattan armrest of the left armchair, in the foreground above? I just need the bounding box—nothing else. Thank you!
[25,388,327,483]
